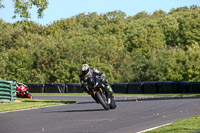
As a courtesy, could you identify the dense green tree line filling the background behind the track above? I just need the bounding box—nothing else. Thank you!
[0,5,200,83]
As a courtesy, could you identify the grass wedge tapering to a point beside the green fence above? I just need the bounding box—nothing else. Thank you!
[0,98,75,112]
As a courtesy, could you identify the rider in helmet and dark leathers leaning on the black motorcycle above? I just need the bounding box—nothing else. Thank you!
[80,64,114,102]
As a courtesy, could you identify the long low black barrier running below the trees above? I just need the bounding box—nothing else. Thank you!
[26,81,200,94]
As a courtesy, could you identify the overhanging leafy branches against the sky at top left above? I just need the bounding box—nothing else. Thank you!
[0,0,48,19]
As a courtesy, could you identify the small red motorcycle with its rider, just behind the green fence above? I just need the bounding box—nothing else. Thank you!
[16,84,33,99]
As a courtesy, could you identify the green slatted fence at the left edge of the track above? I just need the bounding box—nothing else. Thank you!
[0,80,16,102]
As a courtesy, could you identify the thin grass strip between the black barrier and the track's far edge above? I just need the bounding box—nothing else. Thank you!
[31,93,200,98]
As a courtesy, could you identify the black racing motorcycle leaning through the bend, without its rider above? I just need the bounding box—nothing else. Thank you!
[86,74,117,110]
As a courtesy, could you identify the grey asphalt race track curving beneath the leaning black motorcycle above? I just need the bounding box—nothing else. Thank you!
[0,96,200,133]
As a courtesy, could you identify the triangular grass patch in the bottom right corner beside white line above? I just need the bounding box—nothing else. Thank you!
[146,115,200,133]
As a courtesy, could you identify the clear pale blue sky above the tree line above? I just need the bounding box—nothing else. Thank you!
[0,0,200,25]
